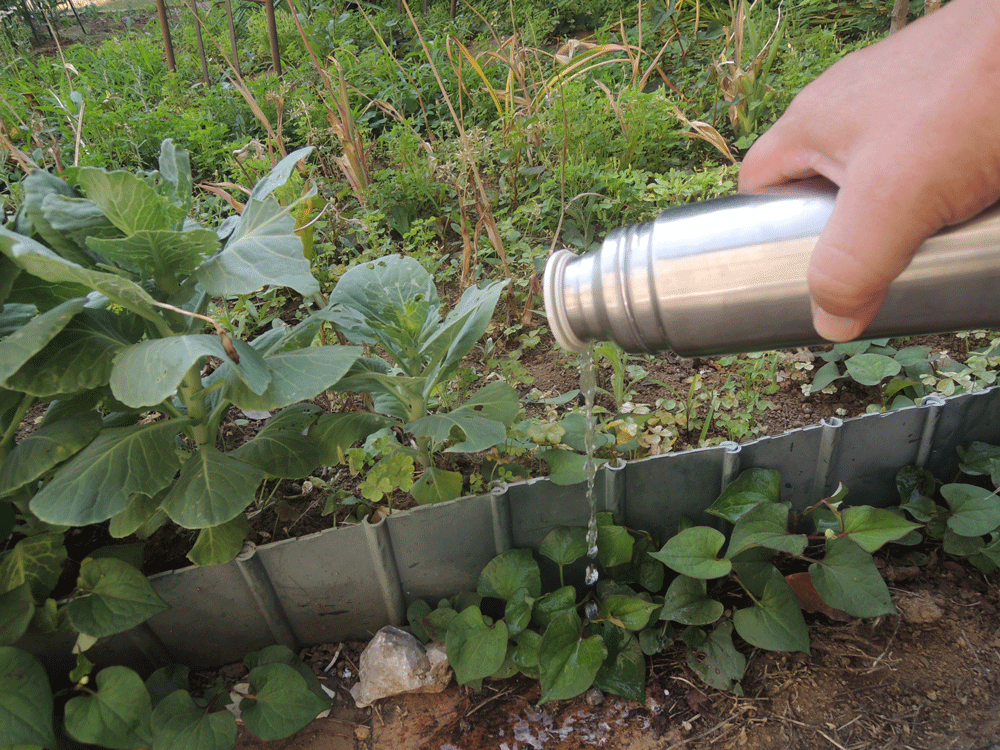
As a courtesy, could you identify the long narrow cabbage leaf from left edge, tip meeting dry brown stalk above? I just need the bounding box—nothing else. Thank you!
[0,227,161,323]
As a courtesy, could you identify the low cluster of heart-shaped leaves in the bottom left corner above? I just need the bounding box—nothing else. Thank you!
[0,646,330,750]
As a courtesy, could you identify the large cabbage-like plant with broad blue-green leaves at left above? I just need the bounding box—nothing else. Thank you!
[0,141,360,569]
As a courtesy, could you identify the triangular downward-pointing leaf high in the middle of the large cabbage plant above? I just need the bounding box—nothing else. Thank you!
[87,229,219,294]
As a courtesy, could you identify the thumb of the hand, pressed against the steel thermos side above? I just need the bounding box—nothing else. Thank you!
[808,180,940,341]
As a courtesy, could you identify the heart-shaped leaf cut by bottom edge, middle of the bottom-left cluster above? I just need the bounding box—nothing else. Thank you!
[151,690,237,750]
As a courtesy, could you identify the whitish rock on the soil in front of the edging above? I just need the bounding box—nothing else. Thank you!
[351,625,451,708]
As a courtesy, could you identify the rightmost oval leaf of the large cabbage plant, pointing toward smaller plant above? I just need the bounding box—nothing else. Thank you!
[220,346,361,411]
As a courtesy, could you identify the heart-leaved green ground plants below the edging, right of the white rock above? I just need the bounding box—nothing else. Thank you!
[408,443,1000,703]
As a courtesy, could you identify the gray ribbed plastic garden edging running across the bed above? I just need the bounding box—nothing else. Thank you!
[18,388,1000,672]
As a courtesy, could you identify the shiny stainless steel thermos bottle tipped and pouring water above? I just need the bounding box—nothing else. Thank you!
[544,180,1000,356]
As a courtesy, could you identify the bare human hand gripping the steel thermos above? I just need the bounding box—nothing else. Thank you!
[740,0,1000,341]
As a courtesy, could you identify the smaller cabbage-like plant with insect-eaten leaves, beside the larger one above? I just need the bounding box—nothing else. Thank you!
[315,256,520,503]
